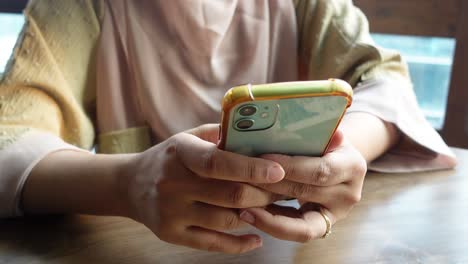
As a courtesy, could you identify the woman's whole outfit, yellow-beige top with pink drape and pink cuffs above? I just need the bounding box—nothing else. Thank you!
[0,0,453,217]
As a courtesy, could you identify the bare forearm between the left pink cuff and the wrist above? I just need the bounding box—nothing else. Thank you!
[22,150,135,216]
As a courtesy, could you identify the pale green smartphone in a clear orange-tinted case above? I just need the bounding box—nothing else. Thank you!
[218,79,353,156]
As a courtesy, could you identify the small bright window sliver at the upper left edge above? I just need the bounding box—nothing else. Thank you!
[0,13,24,75]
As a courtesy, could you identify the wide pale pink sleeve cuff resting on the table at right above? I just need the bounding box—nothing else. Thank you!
[347,79,456,173]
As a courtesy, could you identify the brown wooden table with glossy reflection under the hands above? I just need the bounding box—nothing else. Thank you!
[0,149,468,263]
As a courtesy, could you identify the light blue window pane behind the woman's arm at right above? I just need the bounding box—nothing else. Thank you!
[372,34,455,129]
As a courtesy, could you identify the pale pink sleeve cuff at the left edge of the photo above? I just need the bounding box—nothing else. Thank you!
[0,132,82,218]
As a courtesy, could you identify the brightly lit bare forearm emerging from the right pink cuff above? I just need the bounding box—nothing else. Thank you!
[341,112,400,162]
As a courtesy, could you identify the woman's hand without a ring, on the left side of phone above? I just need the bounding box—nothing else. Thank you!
[122,125,284,253]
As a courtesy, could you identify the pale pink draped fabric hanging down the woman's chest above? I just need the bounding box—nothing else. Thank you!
[97,0,298,140]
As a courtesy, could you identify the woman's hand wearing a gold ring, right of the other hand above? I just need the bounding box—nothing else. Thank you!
[240,131,367,242]
